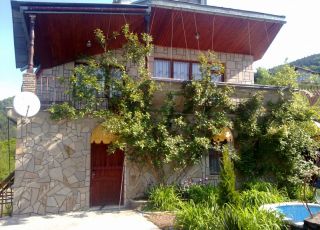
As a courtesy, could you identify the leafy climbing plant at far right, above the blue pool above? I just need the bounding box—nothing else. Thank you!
[235,89,319,197]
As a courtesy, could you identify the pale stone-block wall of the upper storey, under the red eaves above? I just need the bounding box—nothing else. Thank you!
[35,46,254,105]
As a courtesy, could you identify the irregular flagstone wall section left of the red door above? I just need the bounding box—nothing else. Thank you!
[13,112,96,215]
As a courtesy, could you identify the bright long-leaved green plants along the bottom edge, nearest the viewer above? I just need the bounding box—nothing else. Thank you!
[176,202,286,230]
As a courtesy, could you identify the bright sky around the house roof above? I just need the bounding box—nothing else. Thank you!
[0,0,320,100]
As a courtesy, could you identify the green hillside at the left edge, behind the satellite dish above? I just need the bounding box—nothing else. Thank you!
[0,97,16,141]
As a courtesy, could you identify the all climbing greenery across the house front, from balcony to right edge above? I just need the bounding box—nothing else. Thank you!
[49,26,319,189]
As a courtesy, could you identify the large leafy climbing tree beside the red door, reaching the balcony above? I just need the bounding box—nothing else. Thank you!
[50,26,231,184]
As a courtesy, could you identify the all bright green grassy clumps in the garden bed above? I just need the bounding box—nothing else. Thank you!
[148,184,288,230]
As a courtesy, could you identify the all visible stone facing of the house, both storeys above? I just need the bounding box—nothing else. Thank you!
[13,47,264,215]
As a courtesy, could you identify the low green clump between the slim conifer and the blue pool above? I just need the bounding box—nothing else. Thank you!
[239,189,288,207]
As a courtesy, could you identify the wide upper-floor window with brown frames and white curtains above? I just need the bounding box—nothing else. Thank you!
[153,59,224,82]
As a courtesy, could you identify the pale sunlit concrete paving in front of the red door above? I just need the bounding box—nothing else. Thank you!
[0,210,159,230]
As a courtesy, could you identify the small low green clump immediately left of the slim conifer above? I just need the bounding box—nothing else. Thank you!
[184,185,218,205]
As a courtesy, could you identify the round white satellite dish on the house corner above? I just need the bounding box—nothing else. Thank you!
[13,92,40,117]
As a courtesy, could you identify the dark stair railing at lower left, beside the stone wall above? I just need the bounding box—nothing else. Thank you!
[0,172,14,217]
